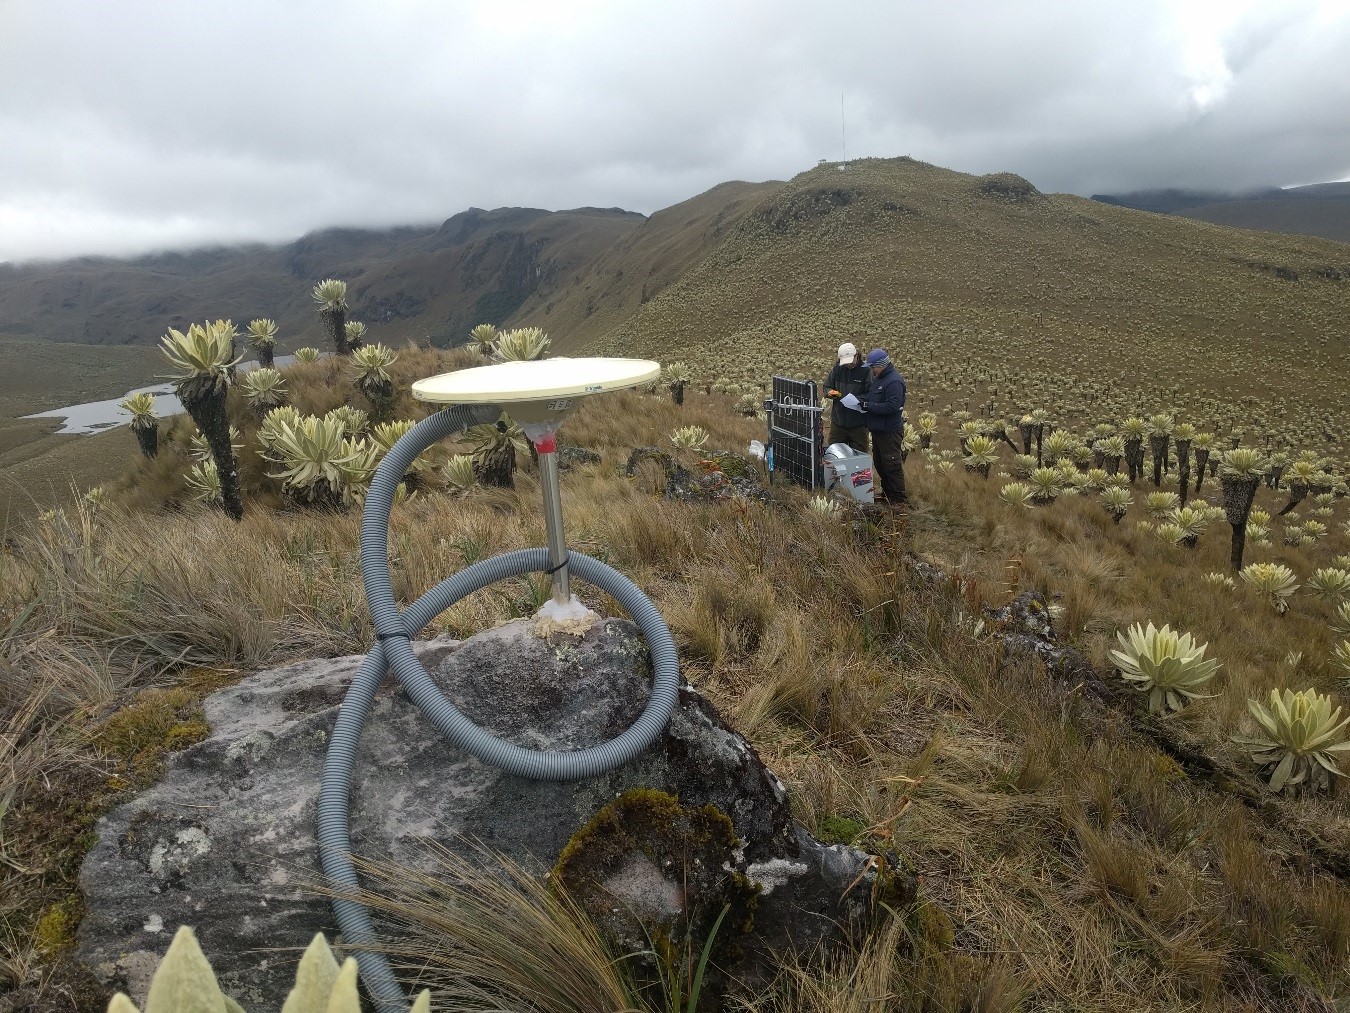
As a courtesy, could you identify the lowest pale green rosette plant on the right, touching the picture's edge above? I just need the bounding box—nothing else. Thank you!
[1234,689,1350,791]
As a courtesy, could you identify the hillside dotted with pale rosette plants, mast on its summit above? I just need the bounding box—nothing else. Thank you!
[586,158,1350,452]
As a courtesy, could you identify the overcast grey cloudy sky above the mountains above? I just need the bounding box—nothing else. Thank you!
[0,0,1350,261]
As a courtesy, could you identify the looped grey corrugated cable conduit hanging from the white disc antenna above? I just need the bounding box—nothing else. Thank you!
[317,405,679,1013]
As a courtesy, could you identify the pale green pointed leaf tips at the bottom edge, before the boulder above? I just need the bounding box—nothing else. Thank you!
[108,925,431,1013]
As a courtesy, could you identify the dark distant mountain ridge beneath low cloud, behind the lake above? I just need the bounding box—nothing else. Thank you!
[0,208,644,348]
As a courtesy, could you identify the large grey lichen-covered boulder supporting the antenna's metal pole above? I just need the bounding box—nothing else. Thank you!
[78,620,907,1008]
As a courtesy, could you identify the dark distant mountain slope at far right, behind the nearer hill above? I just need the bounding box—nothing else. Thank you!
[1092,182,1350,243]
